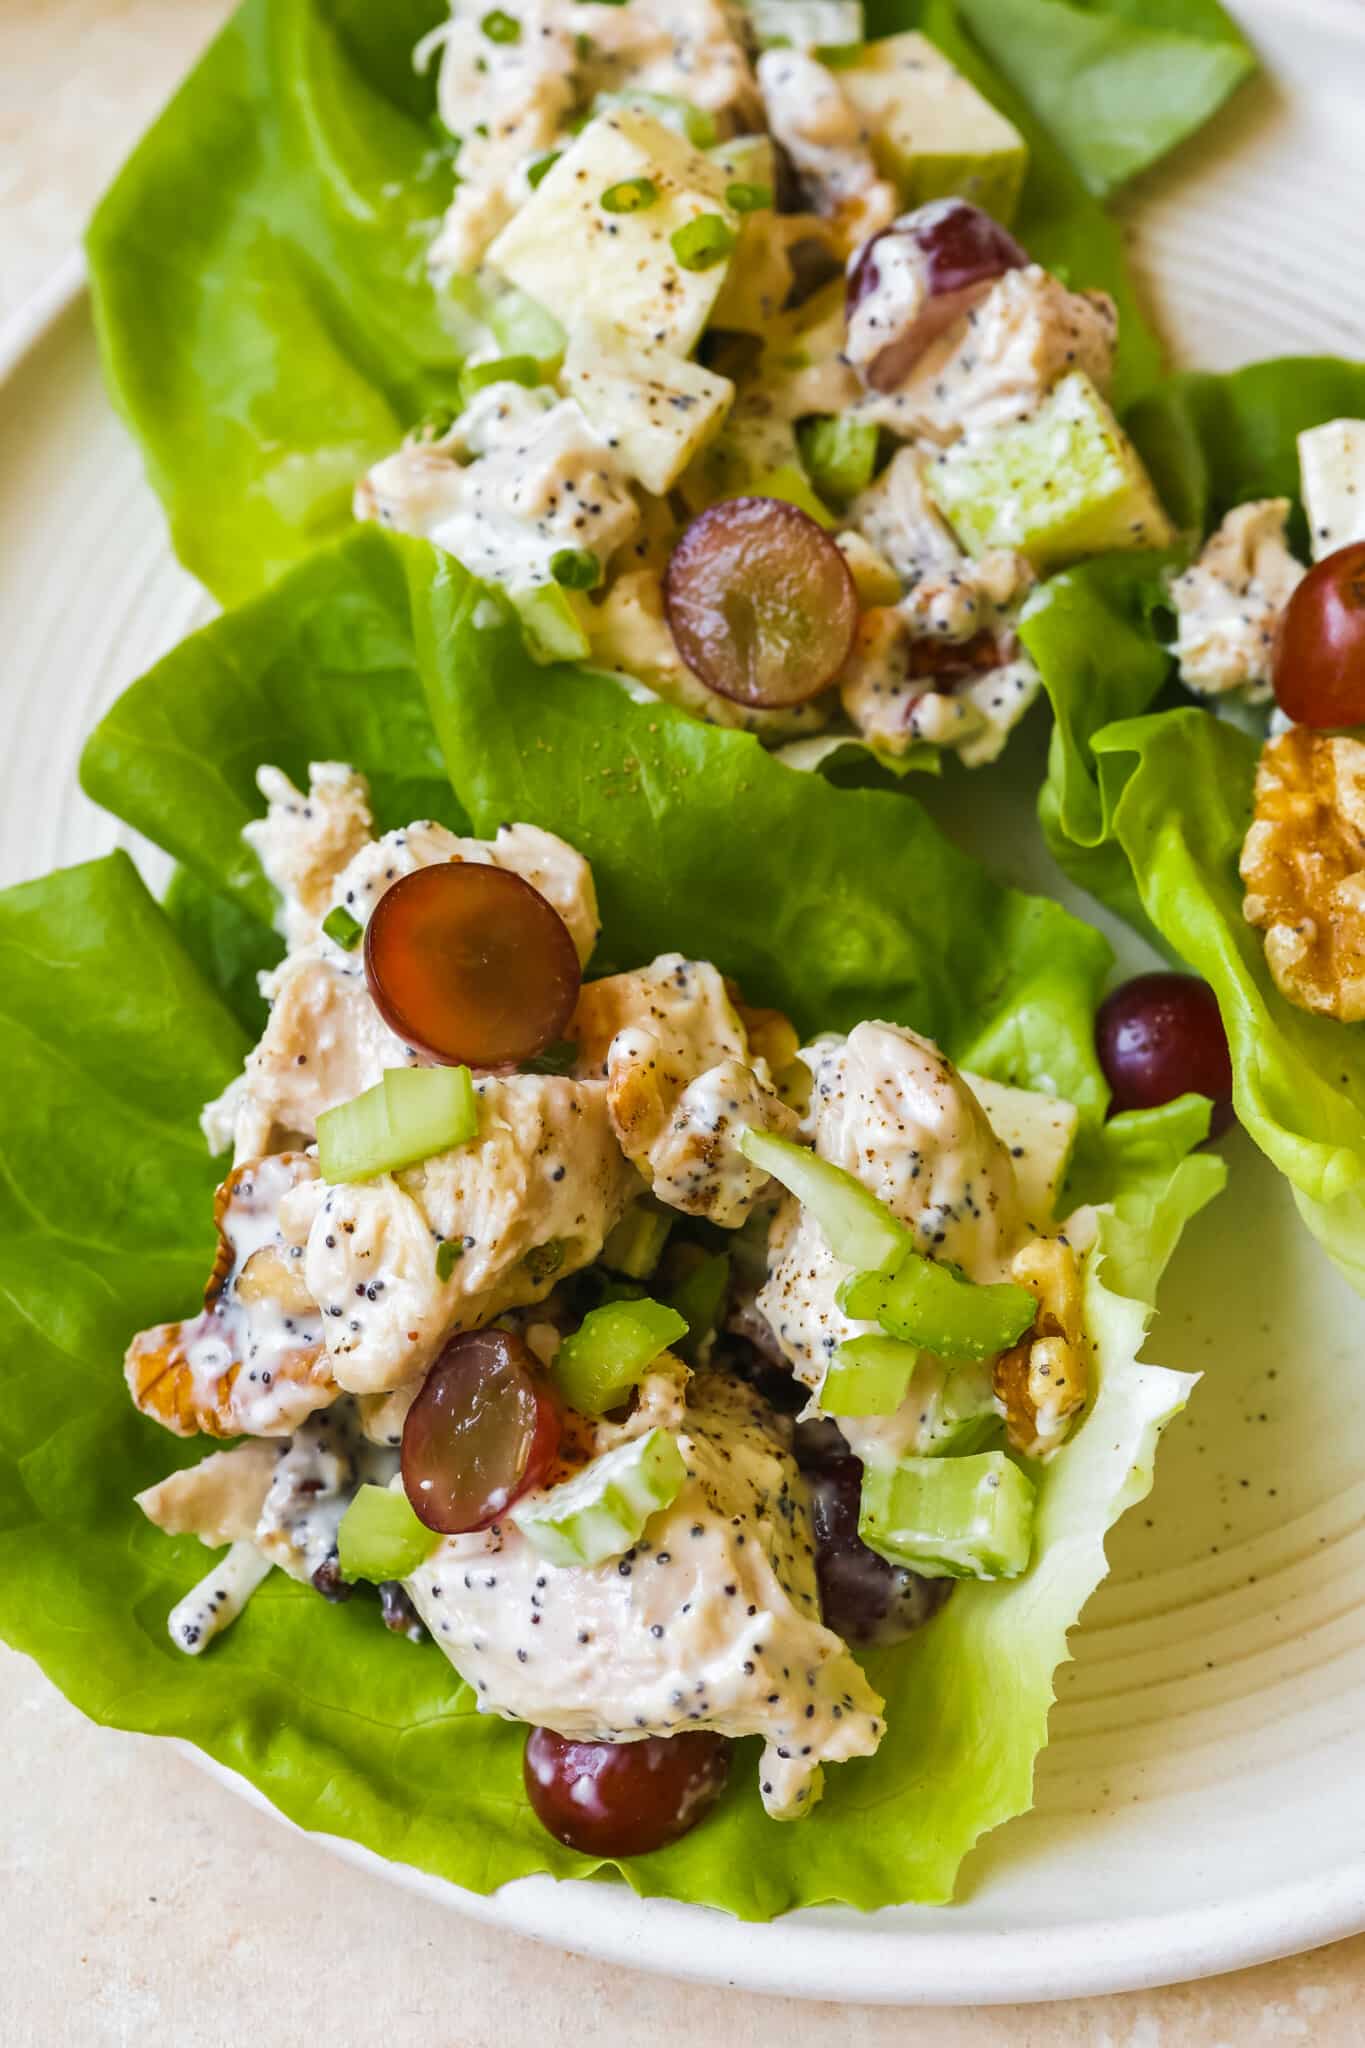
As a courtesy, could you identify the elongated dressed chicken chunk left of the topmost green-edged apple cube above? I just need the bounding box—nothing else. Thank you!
[757,49,896,250]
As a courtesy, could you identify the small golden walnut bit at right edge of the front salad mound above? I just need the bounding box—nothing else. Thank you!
[995,1237,1087,1458]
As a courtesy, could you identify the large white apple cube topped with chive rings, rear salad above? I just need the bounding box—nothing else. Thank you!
[487,106,741,356]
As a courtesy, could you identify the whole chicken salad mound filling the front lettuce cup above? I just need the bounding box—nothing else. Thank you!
[127,762,1095,1853]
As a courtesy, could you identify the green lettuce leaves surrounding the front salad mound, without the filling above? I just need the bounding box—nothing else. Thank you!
[0,532,1222,1919]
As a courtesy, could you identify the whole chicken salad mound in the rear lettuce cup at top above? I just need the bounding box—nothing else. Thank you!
[354,0,1178,768]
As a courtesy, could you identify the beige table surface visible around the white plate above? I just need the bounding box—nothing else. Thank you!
[0,0,1365,2048]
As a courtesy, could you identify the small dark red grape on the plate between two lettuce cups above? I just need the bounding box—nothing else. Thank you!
[1095,973,1232,1137]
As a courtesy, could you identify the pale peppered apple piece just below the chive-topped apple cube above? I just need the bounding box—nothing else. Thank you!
[559,322,735,496]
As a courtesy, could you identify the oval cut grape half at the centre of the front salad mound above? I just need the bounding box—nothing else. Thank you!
[401,1329,561,1536]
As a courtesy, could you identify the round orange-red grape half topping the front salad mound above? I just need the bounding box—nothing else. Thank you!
[364,860,581,1067]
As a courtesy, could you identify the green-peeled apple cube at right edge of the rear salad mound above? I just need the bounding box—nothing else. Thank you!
[925,371,1175,573]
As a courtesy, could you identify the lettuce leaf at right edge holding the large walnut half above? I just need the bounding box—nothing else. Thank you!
[1039,356,1365,1292]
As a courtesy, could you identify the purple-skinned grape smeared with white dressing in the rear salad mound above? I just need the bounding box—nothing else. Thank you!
[845,199,1029,391]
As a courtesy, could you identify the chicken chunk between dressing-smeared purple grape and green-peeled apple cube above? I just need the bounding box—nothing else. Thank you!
[857,264,1117,442]
